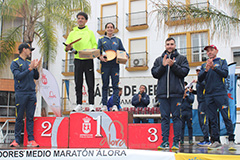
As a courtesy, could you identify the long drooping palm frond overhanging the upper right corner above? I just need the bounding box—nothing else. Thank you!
[151,1,240,34]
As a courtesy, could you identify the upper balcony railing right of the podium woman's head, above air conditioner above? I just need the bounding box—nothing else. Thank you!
[126,11,148,27]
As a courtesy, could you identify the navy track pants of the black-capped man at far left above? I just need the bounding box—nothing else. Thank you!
[15,93,37,144]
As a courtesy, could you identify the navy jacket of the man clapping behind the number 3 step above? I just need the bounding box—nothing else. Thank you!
[132,92,150,107]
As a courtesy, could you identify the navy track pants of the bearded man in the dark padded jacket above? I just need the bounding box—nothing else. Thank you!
[159,97,182,142]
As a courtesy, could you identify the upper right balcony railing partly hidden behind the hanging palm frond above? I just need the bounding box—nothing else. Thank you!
[167,2,210,21]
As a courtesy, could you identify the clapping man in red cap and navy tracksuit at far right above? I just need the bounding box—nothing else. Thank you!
[198,45,235,150]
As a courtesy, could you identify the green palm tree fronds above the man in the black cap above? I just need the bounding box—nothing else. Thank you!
[0,0,91,67]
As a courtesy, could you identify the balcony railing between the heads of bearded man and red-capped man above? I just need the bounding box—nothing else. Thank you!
[177,46,207,62]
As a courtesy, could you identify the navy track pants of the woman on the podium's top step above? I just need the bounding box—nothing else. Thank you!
[101,66,119,106]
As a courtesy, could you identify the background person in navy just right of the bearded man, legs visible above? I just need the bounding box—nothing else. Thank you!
[181,82,194,144]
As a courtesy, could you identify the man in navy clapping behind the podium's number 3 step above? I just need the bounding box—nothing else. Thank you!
[132,85,150,123]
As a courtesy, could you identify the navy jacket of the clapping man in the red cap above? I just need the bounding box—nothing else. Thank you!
[198,58,228,96]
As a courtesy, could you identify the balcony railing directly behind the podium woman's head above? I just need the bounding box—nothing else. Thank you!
[97,15,118,31]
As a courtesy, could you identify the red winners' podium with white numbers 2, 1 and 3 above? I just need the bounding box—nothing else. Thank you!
[24,111,173,149]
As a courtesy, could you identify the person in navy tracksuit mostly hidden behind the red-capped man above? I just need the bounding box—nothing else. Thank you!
[196,66,211,146]
